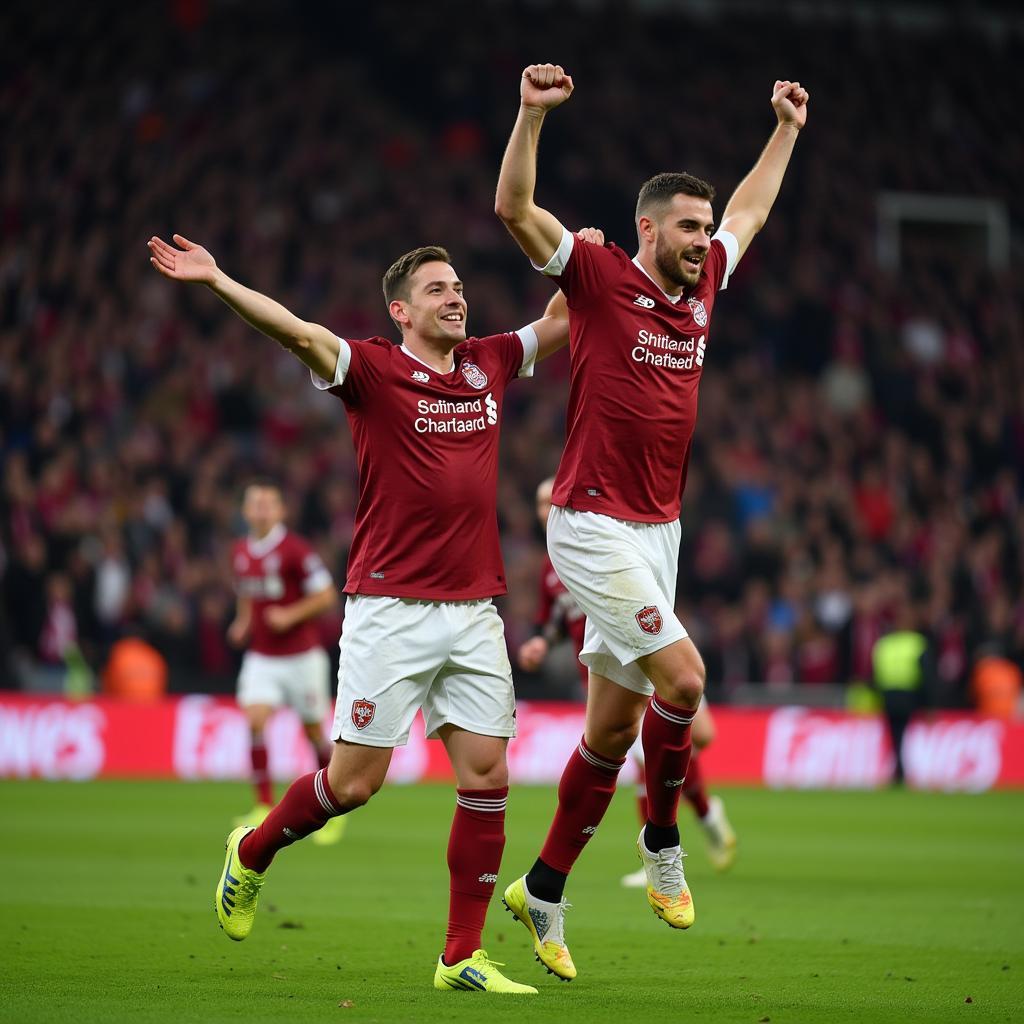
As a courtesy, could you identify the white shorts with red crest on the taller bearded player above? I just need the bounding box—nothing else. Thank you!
[548,505,687,694]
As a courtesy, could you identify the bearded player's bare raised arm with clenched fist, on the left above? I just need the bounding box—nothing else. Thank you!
[495,65,572,266]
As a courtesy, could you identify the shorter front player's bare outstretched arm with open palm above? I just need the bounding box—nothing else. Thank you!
[148,234,341,381]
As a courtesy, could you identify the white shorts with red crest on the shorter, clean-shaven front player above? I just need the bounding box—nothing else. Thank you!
[331,594,515,746]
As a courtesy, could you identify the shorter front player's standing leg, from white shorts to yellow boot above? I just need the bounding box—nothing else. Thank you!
[423,601,537,994]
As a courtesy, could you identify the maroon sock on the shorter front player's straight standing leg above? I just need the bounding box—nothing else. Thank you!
[444,785,509,966]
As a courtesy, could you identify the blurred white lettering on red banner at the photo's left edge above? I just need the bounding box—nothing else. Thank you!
[0,702,106,779]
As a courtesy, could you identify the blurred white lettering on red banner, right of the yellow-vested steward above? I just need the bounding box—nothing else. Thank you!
[903,720,1005,793]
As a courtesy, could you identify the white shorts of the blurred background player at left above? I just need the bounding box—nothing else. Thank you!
[238,647,331,725]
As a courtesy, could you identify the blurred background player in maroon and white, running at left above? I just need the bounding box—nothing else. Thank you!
[227,480,345,843]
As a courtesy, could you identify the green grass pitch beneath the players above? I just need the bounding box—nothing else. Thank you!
[0,782,1024,1024]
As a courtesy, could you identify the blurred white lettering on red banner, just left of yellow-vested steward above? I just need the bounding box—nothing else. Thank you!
[764,708,892,790]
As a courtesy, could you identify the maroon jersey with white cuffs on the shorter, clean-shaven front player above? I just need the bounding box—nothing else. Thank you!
[318,328,537,601]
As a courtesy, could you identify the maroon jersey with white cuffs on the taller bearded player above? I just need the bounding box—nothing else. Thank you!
[544,231,736,522]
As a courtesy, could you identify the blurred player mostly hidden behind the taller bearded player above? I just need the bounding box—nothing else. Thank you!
[517,476,736,889]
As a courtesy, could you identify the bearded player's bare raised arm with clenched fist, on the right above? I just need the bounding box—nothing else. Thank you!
[721,82,810,256]
